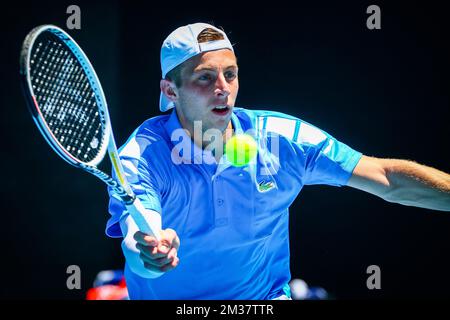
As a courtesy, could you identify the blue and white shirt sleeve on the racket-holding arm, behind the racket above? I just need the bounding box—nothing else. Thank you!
[106,137,162,238]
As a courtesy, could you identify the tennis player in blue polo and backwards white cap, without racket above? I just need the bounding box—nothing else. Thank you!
[106,23,450,300]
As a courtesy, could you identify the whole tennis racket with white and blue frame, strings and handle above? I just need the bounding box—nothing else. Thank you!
[20,25,161,238]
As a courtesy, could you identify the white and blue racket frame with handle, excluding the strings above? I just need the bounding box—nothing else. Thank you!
[20,25,161,239]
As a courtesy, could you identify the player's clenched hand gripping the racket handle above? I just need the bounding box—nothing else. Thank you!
[133,229,180,272]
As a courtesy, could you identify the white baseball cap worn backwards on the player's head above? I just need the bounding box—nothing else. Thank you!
[159,23,234,112]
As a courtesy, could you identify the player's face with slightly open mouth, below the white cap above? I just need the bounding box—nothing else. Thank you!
[176,49,239,132]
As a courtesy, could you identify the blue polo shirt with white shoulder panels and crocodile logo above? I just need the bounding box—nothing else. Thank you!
[106,108,361,300]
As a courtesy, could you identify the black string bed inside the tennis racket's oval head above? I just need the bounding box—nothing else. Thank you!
[30,32,104,162]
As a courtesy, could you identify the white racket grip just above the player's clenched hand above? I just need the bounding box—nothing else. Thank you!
[125,198,162,240]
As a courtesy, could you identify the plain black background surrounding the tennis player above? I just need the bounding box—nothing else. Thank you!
[0,1,450,299]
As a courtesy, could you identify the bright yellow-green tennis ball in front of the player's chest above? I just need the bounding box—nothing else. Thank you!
[225,134,258,167]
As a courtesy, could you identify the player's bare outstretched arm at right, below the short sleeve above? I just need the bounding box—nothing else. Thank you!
[347,155,450,211]
